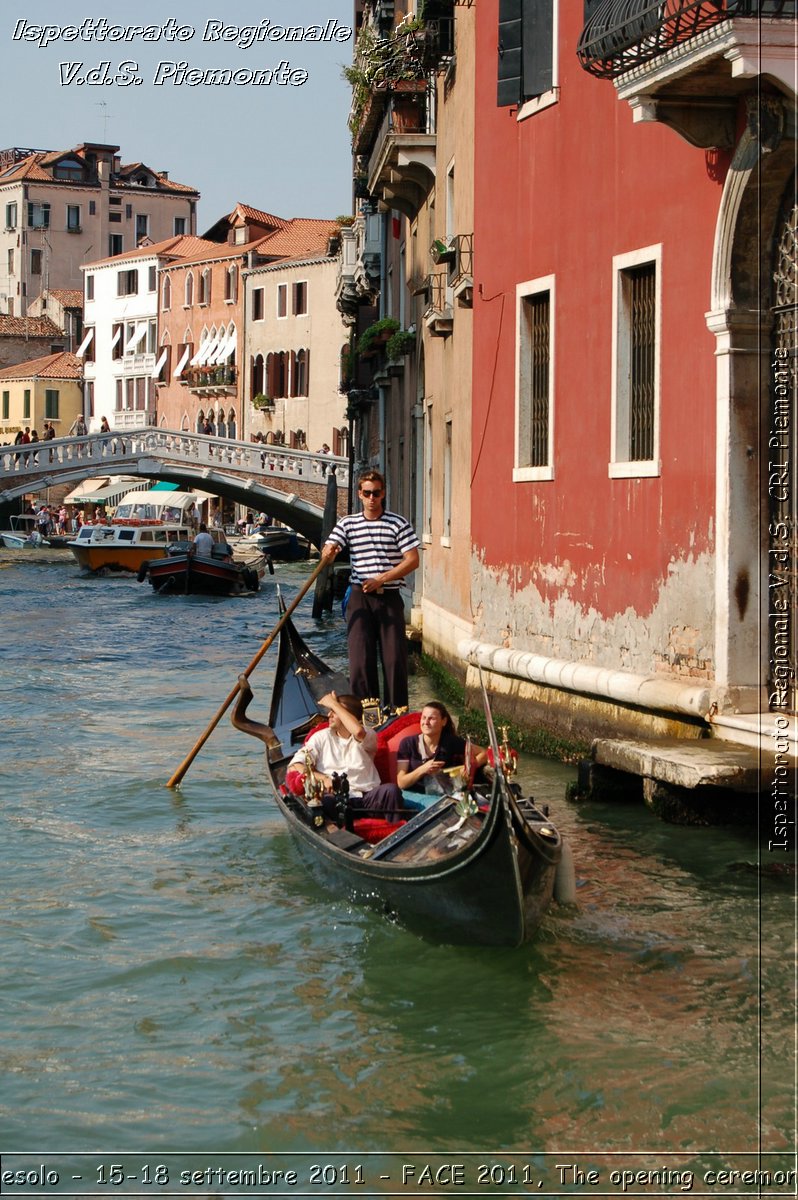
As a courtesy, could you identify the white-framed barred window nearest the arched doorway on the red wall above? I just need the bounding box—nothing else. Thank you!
[610,246,661,478]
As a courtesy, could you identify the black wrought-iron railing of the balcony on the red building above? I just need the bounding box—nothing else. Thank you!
[576,0,796,79]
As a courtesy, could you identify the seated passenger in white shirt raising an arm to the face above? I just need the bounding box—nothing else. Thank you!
[287,691,403,821]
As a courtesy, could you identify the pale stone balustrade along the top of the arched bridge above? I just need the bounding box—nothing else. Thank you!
[0,428,349,486]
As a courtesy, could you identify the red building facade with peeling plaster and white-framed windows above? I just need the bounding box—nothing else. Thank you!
[470,0,796,730]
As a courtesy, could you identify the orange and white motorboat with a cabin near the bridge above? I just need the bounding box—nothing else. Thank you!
[67,488,199,575]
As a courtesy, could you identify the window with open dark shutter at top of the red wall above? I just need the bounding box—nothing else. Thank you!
[497,0,557,116]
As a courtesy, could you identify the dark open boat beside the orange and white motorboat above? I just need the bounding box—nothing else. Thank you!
[137,541,268,596]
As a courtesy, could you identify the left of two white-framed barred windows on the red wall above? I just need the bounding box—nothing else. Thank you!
[512,276,554,482]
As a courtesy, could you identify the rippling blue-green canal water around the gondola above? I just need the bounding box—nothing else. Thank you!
[0,552,794,1195]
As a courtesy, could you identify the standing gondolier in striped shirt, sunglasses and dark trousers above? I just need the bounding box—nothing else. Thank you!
[322,470,419,708]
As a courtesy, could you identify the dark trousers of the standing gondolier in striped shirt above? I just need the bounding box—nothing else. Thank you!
[347,584,407,708]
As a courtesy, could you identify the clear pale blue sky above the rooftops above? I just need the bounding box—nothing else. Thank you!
[0,0,354,233]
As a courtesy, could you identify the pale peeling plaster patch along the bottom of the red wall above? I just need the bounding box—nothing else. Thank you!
[472,544,714,680]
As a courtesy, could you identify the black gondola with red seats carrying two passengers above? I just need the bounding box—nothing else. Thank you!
[232,600,571,946]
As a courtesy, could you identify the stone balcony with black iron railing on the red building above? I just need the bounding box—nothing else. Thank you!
[577,0,796,149]
